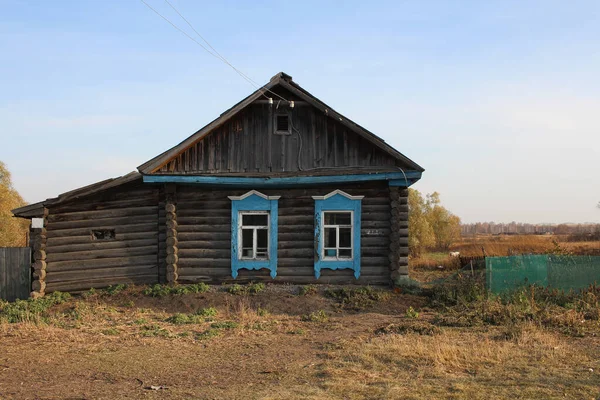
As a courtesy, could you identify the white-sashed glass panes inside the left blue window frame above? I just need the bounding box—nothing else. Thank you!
[238,211,269,260]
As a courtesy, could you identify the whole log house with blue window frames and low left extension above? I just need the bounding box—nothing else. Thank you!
[13,73,423,295]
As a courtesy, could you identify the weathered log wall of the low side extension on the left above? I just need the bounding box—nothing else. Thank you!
[45,183,159,292]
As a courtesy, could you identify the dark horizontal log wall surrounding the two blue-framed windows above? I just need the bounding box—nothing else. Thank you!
[176,183,398,285]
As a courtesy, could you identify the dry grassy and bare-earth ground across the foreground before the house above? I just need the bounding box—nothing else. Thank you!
[0,282,600,399]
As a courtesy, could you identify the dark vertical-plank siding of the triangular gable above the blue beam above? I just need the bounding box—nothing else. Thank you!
[156,104,396,174]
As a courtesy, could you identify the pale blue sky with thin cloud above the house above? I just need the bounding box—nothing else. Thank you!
[0,0,600,223]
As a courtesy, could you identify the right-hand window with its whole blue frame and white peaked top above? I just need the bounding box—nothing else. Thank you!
[313,190,364,279]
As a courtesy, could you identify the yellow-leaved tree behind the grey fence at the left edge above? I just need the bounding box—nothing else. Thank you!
[0,161,29,247]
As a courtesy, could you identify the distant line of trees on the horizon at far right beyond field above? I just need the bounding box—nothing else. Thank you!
[460,222,600,238]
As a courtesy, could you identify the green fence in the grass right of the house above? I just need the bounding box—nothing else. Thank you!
[485,254,600,293]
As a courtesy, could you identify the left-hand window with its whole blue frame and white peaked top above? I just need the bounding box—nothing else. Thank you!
[229,190,280,279]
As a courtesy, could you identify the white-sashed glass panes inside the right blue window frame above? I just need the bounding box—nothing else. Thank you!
[322,211,352,260]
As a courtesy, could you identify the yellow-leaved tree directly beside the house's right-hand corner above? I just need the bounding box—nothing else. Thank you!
[408,189,435,257]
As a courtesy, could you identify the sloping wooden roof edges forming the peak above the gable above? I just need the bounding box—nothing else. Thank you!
[138,72,424,174]
